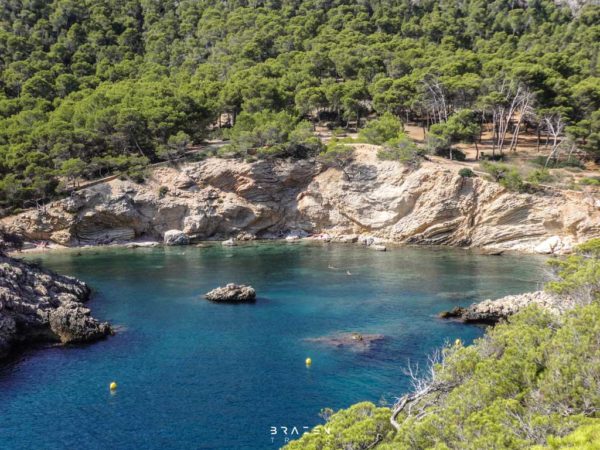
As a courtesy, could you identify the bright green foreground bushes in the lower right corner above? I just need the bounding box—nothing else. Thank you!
[287,239,600,450]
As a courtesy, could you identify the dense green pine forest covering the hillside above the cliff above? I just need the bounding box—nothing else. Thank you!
[0,0,600,212]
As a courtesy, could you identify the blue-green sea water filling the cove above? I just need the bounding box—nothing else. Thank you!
[0,243,544,449]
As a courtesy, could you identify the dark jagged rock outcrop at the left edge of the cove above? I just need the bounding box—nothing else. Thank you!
[0,255,111,358]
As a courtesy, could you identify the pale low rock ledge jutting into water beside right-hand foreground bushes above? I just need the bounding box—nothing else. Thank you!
[440,291,575,324]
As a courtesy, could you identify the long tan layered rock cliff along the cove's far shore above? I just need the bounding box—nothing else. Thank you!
[2,145,600,253]
